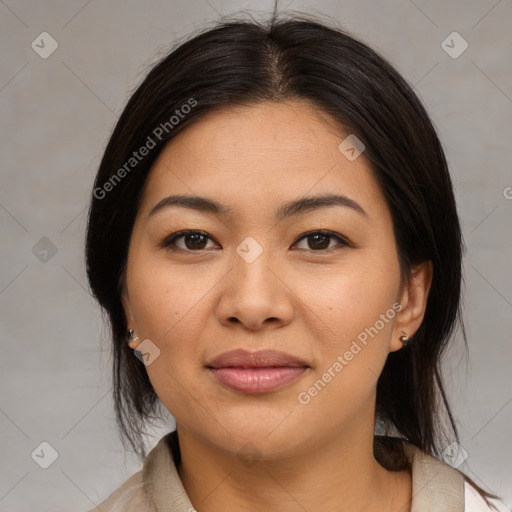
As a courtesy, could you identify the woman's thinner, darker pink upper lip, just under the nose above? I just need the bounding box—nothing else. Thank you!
[206,349,309,368]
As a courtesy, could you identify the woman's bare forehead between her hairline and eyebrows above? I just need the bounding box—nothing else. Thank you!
[138,101,384,220]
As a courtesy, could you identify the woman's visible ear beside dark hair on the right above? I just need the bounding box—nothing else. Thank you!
[389,260,433,352]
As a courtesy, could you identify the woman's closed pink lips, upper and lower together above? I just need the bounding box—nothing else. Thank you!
[206,350,309,394]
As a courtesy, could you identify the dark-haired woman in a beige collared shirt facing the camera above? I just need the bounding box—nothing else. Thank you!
[86,12,504,512]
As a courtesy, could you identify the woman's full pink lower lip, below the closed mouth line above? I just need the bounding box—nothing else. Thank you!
[210,366,307,394]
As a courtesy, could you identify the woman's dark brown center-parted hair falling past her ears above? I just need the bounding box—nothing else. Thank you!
[86,12,496,508]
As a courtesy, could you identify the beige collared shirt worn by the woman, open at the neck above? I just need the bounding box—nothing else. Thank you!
[89,431,501,512]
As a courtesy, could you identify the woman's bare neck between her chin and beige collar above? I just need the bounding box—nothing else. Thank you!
[178,406,412,512]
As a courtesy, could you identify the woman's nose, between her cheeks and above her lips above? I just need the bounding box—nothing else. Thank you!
[217,243,295,331]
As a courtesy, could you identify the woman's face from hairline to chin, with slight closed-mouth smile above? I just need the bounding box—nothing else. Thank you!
[123,102,428,458]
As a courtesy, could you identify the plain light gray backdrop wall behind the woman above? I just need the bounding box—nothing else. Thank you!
[0,0,512,512]
